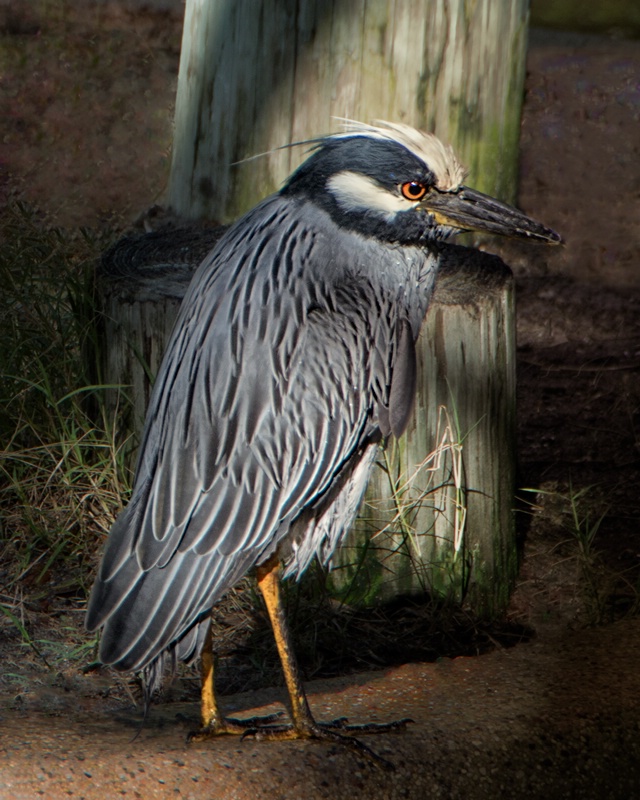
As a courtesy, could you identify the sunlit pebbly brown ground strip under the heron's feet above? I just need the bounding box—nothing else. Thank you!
[0,621,640,800]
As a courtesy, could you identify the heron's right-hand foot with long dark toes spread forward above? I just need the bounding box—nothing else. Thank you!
[242,717,413,771]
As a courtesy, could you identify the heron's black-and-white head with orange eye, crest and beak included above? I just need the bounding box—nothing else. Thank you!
[282,122,561,244]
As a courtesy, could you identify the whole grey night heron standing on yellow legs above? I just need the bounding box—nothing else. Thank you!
[87,123,559,764]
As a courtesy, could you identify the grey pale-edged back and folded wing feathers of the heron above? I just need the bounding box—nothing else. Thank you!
[87,195,415,669]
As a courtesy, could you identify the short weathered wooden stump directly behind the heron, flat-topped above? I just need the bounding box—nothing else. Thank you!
[98,231,517,615]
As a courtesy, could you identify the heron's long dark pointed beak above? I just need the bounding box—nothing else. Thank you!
[418,186,562,244]
